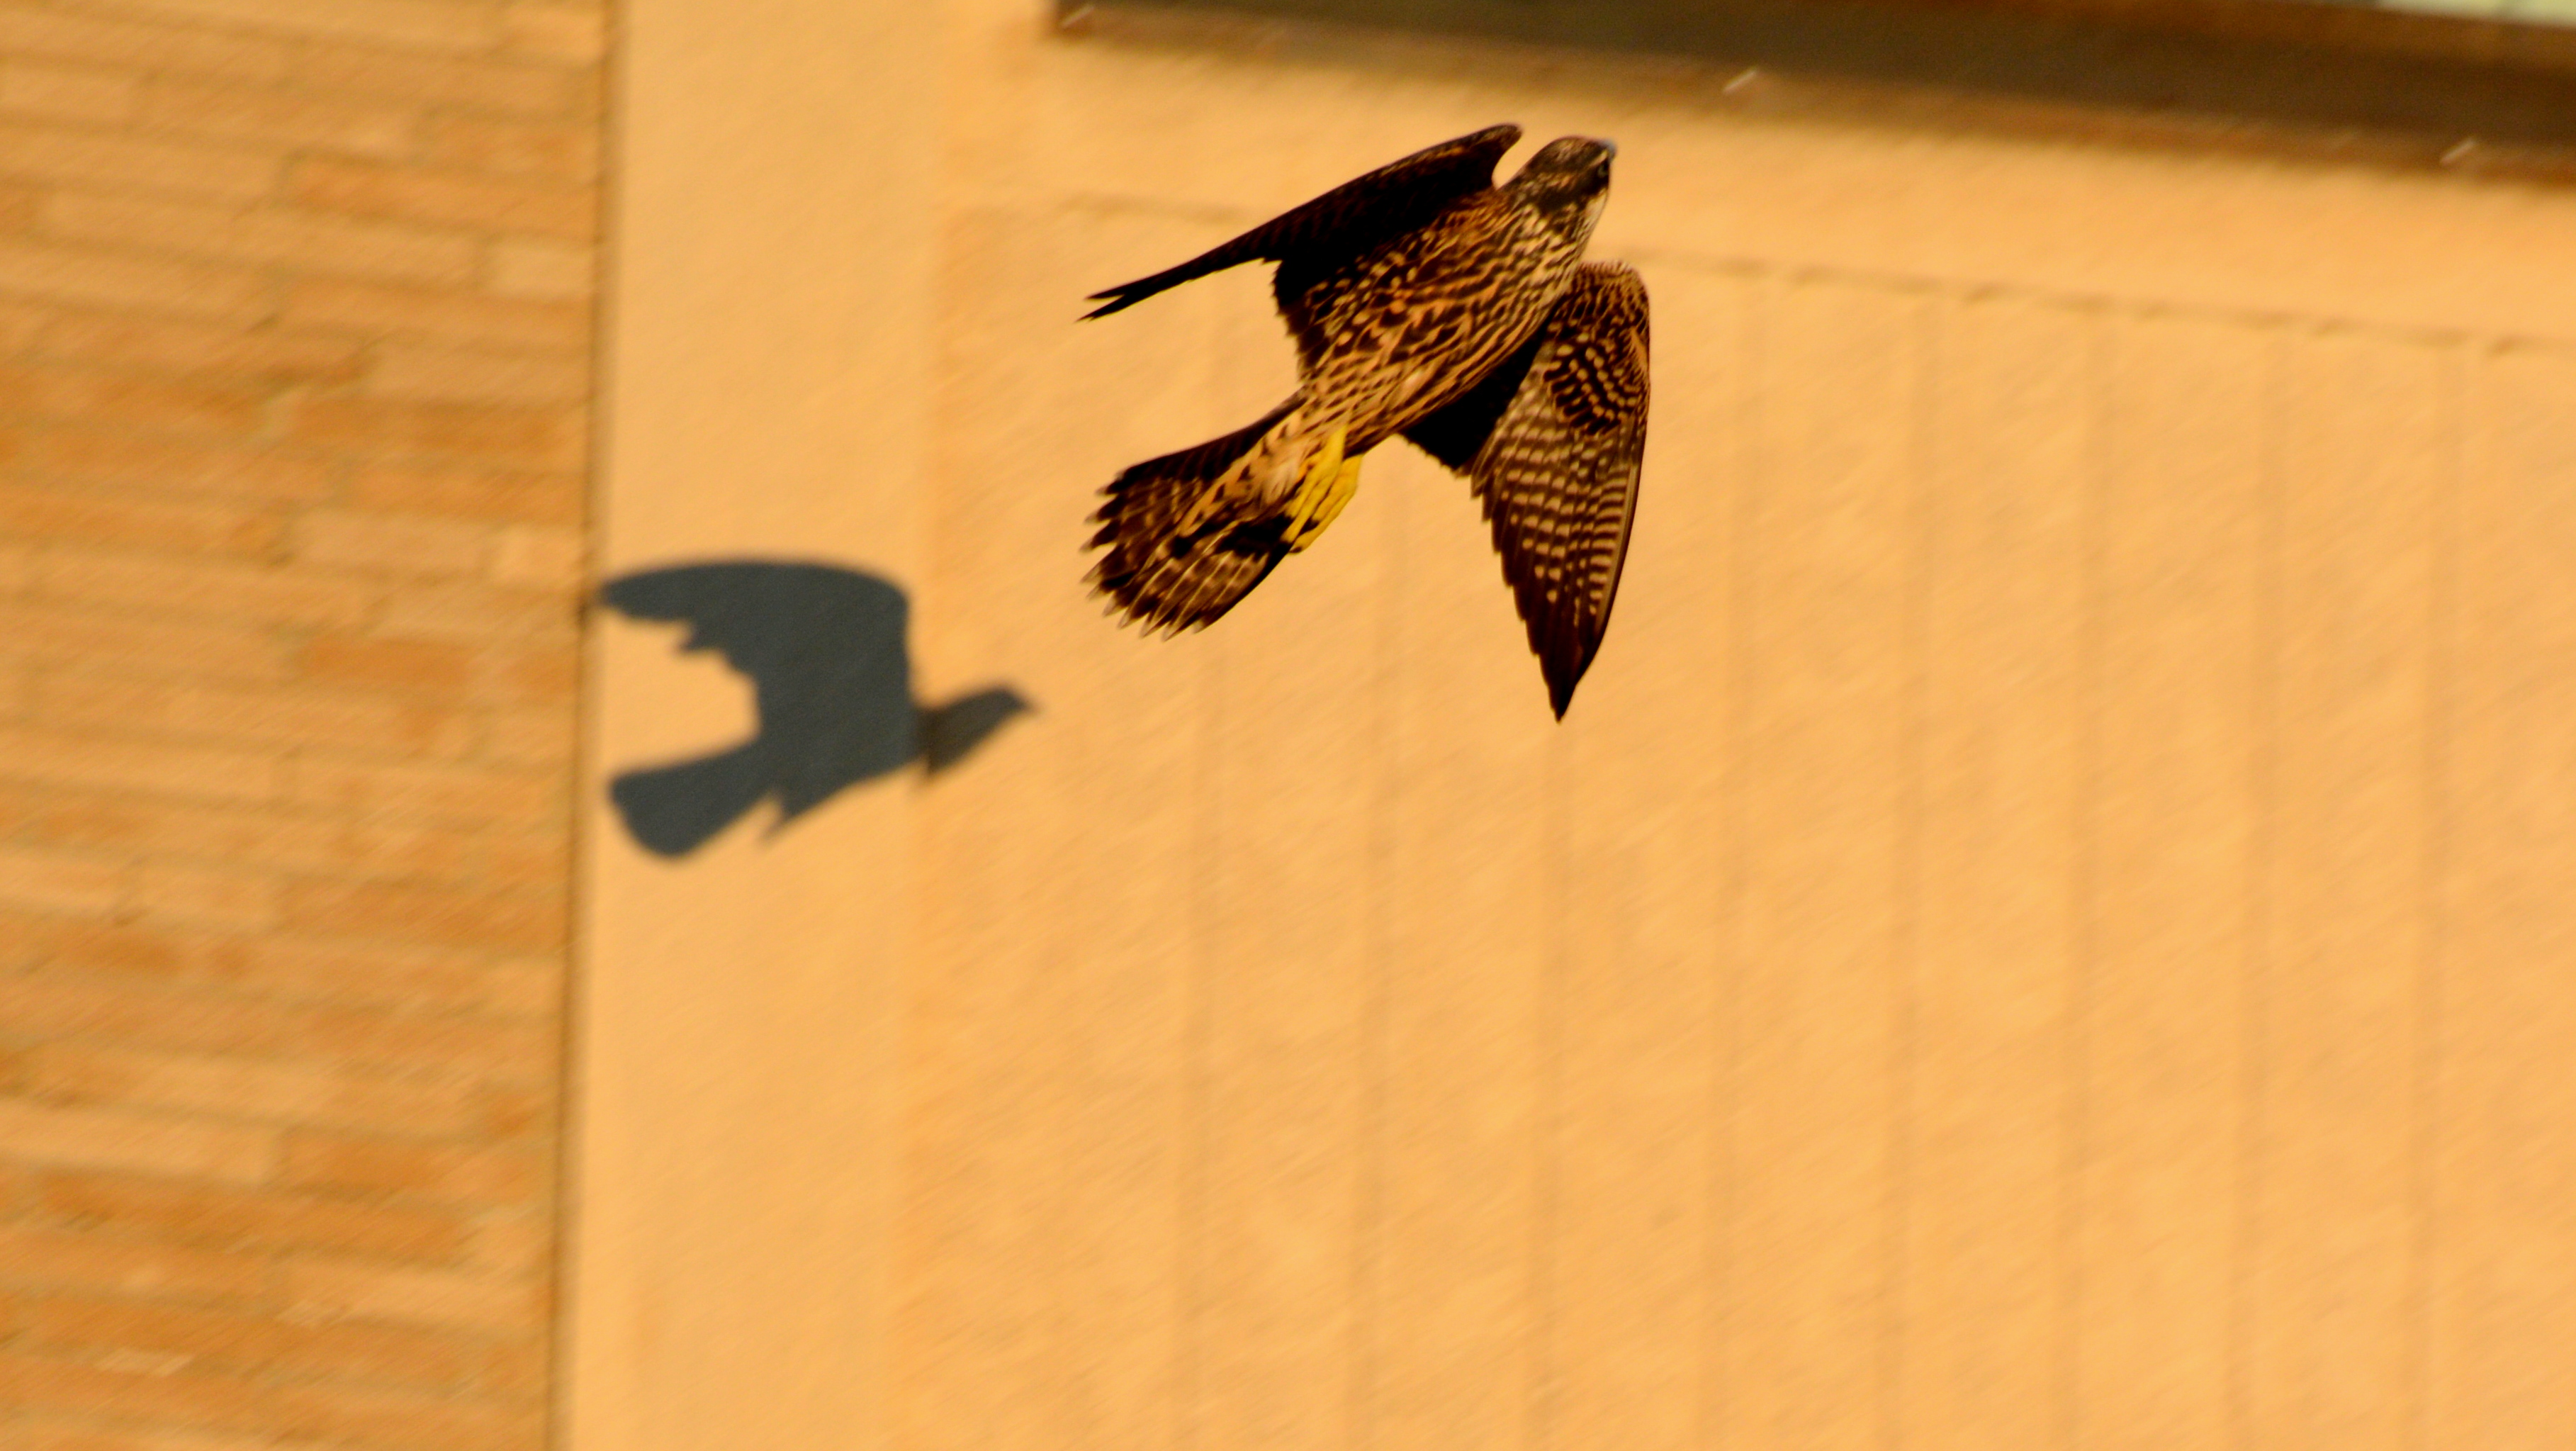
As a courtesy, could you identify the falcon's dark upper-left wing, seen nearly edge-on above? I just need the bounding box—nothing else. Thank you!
[1084,126,1520,317]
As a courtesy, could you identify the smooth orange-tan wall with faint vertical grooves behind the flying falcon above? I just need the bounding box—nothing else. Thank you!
[564,0,2576,1451]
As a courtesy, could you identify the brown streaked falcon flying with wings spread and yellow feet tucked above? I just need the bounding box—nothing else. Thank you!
[1090,126,1646,719]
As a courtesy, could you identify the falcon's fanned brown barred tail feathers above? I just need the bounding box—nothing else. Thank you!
[1090,400,1311,634]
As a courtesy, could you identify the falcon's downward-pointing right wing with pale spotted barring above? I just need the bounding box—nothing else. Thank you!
[1404,263,1646,719]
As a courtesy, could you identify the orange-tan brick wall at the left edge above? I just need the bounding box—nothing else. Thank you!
[0,0,605,1451]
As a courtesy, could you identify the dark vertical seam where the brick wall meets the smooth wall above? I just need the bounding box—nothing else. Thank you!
[544,0,626,1451]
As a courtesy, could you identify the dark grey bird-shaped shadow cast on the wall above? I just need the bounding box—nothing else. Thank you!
[600,559,1033,856]
